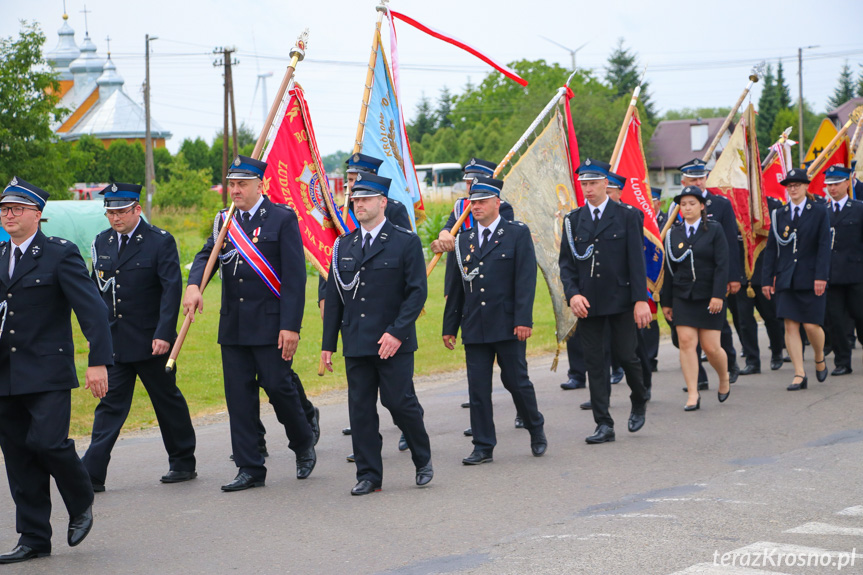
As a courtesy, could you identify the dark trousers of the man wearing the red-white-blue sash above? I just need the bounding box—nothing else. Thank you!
[222,345,315,481]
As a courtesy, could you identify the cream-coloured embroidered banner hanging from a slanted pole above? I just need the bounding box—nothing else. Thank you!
[501,109,578,369]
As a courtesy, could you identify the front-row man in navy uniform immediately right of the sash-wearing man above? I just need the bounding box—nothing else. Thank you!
[321,174,434,495]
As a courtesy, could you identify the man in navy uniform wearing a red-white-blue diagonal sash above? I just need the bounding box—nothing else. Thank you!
[183,156,317,491]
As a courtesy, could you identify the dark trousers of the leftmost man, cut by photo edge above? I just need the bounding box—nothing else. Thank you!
[0,389,93,552]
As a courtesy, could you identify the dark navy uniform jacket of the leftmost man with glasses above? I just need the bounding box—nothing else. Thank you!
[0,231,114,395]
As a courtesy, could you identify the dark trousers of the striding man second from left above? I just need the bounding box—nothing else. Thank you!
[82,355,195,483]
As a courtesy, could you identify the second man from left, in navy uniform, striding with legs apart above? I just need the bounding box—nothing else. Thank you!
[83,183,197,493]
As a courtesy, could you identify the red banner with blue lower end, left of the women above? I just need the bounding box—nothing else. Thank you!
[611,108,665,294]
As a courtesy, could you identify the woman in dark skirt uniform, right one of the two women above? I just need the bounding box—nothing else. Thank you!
[761,168,830,391]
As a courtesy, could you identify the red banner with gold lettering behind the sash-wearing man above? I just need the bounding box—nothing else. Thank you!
[262,85,344,281]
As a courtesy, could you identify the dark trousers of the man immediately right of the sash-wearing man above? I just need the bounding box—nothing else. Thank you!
[345,352,431,485]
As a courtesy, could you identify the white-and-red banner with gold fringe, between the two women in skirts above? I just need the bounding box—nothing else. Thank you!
[706,103,770,284]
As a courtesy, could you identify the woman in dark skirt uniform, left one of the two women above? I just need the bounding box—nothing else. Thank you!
[659,186,731,411]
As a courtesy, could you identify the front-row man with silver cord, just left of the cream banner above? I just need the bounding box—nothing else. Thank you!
[442,176,548,465]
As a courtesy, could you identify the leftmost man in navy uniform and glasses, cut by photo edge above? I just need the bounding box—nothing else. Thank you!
[0,178,113,564]
